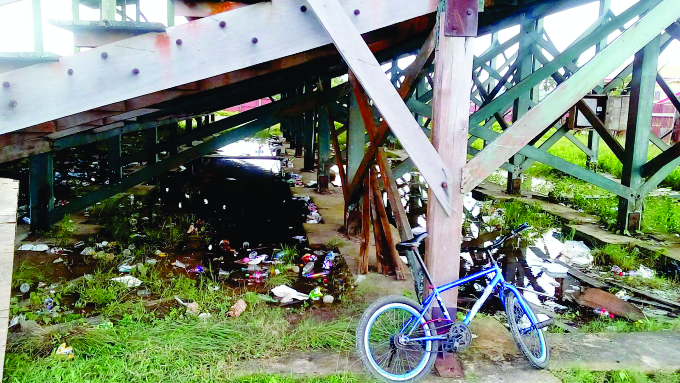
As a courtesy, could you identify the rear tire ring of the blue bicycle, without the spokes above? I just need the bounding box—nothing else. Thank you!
[356,295,438,382]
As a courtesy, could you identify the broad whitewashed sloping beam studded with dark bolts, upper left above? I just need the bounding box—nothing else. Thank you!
[0,0,437,133]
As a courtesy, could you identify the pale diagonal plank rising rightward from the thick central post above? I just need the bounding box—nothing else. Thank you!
[462,0,680,193]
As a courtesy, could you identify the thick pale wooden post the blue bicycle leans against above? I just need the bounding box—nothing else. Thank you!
[425,2,477,318]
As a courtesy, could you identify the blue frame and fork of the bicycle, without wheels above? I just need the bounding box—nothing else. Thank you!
[401,262,537,342]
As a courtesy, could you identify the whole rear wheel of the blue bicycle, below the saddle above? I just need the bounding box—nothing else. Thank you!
[356,296,437,382]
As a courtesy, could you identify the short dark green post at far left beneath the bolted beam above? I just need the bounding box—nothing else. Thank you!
[28,152,54,228]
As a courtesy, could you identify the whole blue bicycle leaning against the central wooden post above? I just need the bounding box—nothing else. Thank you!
[356,223,552,382]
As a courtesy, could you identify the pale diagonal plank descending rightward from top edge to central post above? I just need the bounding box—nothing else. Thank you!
[308,0,454,214]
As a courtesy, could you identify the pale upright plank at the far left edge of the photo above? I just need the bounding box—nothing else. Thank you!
[0,178,19,378]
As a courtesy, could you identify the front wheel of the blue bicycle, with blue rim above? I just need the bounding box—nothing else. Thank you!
[505,291,550,369]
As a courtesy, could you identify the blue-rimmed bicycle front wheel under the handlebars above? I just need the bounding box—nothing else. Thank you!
[505,291,549,369]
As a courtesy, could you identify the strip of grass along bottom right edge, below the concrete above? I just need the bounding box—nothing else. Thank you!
[553,369,680,383]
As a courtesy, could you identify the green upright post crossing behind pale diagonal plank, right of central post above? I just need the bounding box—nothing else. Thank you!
[506,18,538,194]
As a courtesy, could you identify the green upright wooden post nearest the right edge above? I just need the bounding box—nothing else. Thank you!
[618,36,660,233]
